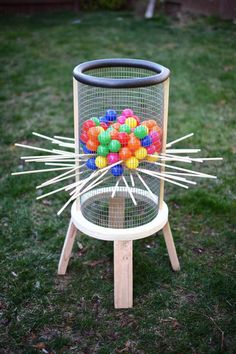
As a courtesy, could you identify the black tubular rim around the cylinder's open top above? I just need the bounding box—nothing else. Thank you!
[73,59,170,88]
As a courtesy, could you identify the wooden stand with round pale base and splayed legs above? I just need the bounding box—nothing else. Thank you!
[58,197,180,308]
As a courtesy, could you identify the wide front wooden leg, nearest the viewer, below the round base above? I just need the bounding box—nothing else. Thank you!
[114,241,133,308]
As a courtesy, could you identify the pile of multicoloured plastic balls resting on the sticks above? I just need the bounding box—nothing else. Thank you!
[80,108,162,176]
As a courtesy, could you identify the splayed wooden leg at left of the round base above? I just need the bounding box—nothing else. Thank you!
[57,220,77,275]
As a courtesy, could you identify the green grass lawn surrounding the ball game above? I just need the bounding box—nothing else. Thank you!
[0,12,236,354]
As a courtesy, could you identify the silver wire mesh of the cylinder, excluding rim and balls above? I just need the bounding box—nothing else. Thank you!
[78,67,164,228]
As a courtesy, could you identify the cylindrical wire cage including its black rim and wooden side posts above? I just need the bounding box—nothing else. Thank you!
[74,59,170,229]
